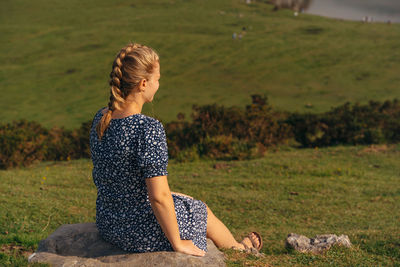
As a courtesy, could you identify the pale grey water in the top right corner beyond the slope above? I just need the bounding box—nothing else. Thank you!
[304,0,400,23]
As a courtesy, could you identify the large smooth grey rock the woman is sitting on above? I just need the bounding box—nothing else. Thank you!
[28,223,226,267]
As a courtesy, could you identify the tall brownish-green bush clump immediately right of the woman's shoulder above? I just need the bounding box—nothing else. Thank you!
[166,95,292,159]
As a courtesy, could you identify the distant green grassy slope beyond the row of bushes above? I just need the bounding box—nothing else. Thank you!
[0,0,400,128]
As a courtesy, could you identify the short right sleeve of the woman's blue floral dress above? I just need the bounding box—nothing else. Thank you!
[138,120,168,178]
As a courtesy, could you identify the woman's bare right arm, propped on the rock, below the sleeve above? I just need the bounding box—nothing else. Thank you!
[146,176,205,256]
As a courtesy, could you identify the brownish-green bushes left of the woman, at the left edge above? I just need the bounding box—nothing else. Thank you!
[0,120,91,169]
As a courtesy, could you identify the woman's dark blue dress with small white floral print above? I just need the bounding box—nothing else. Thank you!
[90,108,207,252]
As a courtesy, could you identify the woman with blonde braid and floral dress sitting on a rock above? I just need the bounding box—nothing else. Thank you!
[90,44,262,256]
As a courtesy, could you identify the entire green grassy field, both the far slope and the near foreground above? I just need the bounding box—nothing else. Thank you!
[0,0,400,266]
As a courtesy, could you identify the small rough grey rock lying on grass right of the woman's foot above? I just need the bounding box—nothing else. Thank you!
[286,233,351,254]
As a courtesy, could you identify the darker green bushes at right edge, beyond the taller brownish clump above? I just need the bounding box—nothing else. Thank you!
[286,99,400,147]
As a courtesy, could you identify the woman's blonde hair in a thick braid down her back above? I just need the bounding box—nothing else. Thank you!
[96,43,159,139]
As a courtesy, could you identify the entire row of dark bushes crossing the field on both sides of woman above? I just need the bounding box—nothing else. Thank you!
[0,95,400,169]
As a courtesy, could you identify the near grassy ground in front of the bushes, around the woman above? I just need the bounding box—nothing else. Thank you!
[0,145,400,266]
